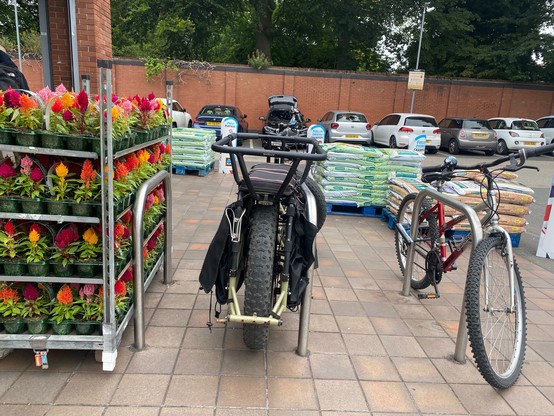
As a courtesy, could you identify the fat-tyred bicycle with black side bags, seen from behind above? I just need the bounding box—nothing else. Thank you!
[199,133,327,349]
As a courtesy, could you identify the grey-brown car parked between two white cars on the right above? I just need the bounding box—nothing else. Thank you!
[439,117,496,156]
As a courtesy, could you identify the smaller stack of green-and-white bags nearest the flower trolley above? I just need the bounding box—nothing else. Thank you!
[171,128,215,169]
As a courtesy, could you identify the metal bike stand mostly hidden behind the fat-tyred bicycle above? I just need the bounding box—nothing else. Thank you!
[296,184,317,357]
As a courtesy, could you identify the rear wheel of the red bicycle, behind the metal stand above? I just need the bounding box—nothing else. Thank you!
[394,194,439,290]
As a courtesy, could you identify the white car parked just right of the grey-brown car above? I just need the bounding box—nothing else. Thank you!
[489,117,544,155]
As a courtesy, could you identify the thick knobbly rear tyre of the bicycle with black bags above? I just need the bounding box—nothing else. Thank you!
[243,205,278,350]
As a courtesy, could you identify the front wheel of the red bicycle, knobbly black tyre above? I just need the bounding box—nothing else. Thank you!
[465,237,527,389]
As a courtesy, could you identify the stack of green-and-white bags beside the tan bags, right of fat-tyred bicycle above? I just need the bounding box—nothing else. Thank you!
[314,143,424,207]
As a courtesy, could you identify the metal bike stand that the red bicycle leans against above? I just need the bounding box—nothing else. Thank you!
[402,189,483,363]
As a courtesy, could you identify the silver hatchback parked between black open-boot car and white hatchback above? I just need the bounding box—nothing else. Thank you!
[318,110,371,144]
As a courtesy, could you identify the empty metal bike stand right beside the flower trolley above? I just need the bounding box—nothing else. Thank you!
[133,170,172,351]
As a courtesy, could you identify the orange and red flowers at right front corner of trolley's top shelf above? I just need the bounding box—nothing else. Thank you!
[49,88,100,135]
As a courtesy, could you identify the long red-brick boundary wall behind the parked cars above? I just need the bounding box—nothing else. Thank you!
[114,60,554,130]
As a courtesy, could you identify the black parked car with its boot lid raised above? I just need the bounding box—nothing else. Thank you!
[260,95,311,136]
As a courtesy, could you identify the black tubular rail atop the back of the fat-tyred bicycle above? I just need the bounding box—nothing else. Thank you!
[212,133,327,162]
